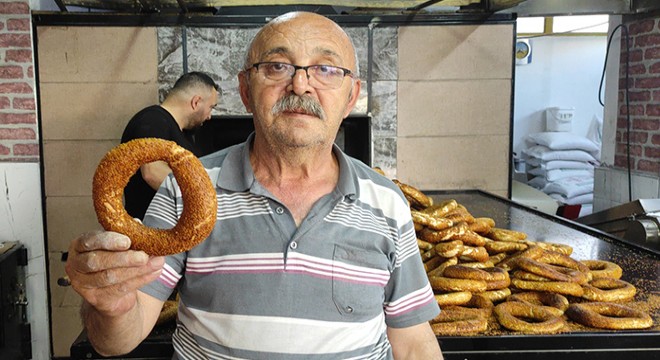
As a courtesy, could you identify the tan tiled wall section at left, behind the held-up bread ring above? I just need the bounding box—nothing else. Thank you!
[37,27,158,356]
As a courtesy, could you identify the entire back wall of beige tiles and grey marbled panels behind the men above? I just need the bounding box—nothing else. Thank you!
[37,25,513,356]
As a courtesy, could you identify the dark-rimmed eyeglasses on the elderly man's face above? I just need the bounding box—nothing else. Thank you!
[247,62,353,90]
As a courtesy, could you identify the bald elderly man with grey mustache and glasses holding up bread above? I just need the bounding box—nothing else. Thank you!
[67,12,442,359]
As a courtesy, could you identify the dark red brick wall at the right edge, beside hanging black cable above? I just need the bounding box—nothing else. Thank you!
[614,13,660,176]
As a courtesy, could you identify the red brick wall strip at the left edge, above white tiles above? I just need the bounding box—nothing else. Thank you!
[0,0,39,162]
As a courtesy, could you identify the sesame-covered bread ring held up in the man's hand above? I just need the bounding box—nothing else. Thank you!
[92,138,217,256]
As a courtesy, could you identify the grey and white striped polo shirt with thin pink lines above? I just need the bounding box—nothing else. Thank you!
[142,135,439,360]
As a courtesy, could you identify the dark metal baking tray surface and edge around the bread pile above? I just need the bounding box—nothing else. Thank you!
[424,190,660,360]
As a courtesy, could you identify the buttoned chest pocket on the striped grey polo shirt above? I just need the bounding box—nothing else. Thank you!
[332,245,390,318]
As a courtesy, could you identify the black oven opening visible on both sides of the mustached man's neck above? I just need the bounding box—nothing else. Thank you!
[195,115,371,166]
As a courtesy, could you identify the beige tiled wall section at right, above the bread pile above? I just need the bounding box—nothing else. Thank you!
[397,25,513,196]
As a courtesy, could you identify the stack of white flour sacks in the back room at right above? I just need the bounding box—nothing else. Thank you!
[523,131,600,216]
